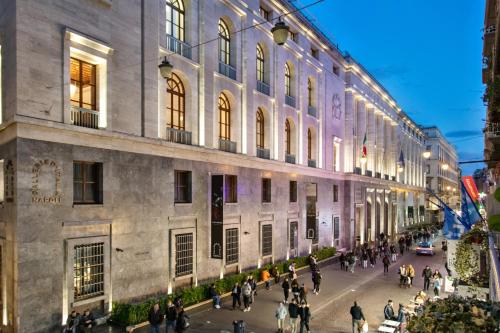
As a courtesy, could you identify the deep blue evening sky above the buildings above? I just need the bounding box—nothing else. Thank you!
[304,0,485,175]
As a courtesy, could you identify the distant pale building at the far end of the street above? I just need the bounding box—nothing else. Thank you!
[423,126,461,222]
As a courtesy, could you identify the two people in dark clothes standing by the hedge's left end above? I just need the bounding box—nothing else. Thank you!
[148,297,189,333]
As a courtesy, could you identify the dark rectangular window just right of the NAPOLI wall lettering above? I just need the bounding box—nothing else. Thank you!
[73,162,103,204]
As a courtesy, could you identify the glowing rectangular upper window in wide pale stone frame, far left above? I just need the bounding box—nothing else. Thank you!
[70,58,97,111]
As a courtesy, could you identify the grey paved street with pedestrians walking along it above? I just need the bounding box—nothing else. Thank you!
[99,239,445,333]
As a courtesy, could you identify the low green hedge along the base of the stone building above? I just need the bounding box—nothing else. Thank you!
[110,247,337,326]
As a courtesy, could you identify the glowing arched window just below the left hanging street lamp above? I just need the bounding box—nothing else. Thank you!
[167,73,186,130]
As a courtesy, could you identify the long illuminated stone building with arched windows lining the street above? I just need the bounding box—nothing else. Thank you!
[0,0,424,332]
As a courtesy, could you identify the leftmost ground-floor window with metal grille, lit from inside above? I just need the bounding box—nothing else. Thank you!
[73,242,104,301]
